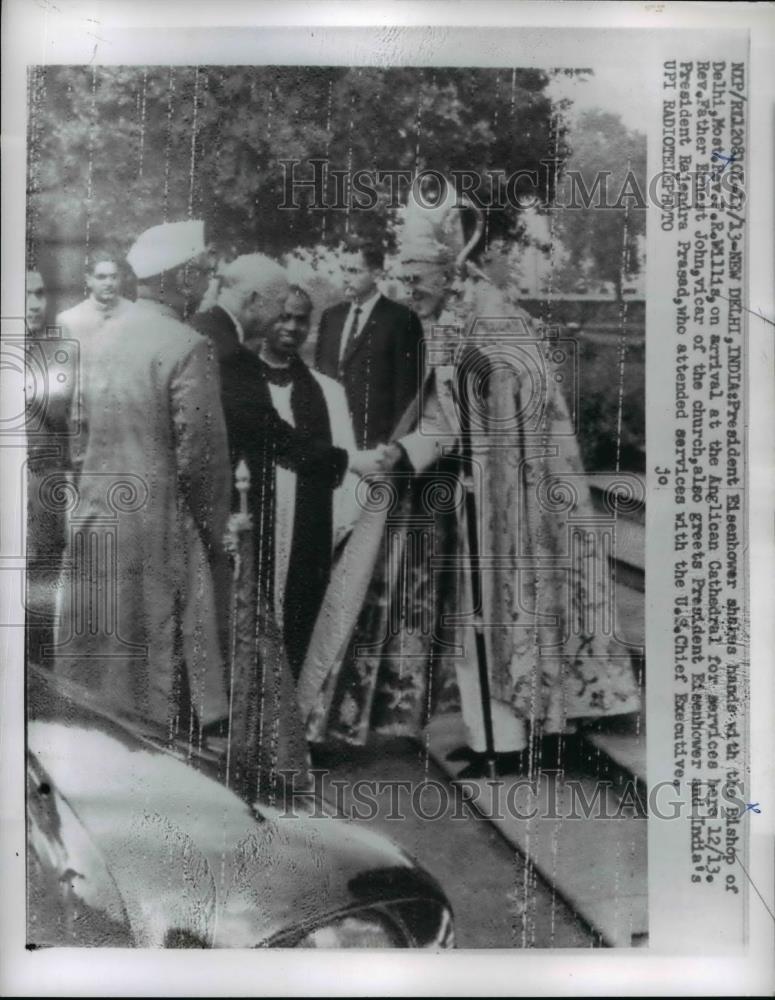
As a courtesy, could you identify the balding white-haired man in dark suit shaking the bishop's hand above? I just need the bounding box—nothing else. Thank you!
[192,254,379,801]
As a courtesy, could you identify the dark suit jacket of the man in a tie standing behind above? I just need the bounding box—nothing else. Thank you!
[315,295,422,448]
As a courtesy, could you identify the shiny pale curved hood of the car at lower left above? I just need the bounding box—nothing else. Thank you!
[28,717,443,948]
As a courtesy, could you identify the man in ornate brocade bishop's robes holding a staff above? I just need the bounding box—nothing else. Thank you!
[299,215,640,776]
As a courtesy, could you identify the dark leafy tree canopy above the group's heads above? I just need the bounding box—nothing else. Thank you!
[29,66,563,254]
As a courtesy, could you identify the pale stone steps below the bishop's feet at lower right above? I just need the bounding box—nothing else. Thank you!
[428,715,648,948]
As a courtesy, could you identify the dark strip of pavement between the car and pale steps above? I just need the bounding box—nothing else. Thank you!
[321,738,604,949]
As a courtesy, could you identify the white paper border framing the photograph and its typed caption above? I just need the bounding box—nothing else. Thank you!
[0,0,775,996]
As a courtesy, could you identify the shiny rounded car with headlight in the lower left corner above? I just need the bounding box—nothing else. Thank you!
[27,666,454,948]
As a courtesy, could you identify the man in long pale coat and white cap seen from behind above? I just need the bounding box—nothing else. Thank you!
[55,222,230,737]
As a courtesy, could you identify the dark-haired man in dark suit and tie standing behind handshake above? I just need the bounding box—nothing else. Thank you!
[315,240,422,448]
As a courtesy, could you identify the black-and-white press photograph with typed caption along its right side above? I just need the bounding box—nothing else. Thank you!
[2,4,772,992]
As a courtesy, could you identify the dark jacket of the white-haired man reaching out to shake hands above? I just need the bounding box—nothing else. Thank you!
[192,306,348,495]
